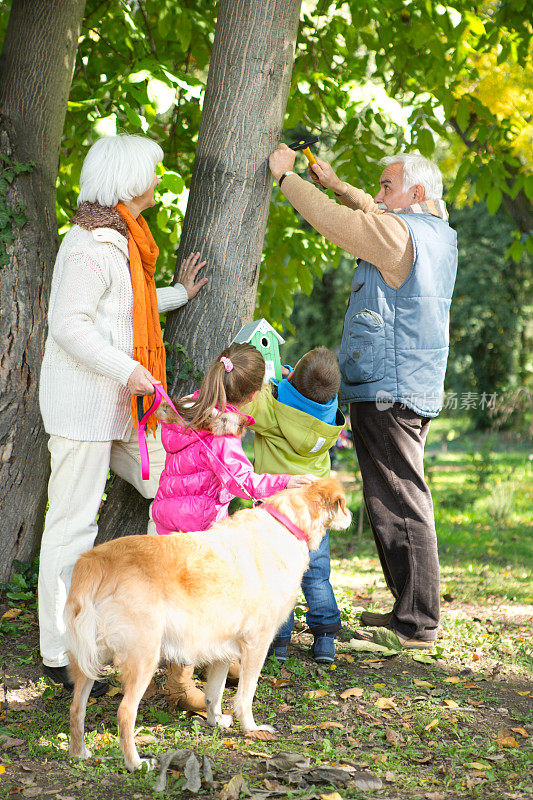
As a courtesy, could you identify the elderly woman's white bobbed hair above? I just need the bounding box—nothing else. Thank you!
[78,133,163,206]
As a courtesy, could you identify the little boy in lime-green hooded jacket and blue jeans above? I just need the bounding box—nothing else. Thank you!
[242,347,345,664]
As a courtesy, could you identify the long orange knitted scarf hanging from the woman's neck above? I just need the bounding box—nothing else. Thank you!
[117,203,167,433]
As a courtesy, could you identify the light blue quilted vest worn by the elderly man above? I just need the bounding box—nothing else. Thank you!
[339,214,457,417]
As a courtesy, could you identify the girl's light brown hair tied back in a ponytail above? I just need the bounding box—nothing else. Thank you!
[174,343,265,430]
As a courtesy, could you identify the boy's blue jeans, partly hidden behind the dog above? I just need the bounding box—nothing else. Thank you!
[274,533,342,645]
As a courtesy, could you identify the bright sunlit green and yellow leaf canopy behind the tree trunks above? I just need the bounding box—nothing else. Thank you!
[0,0,533,318]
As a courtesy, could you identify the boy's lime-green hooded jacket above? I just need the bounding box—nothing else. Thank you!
[241,386,346,478]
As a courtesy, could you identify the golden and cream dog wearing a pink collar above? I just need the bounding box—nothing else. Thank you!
[65,478,351,770]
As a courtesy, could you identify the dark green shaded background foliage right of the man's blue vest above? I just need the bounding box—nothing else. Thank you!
[446,205,533,427]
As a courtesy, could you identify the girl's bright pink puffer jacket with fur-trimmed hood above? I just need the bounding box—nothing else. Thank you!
[152,404,291,534]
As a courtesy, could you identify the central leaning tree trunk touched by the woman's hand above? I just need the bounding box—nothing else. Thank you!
[100,0,301,538]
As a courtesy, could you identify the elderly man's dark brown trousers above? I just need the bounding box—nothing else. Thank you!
[350,402,440,641]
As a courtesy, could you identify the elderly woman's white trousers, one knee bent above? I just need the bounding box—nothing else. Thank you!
[39,428,165,667]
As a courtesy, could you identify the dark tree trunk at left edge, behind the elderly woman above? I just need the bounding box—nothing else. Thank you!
[0,0,85,580]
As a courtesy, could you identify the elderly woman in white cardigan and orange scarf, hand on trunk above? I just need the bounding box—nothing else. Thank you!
[39,135,206,696]
